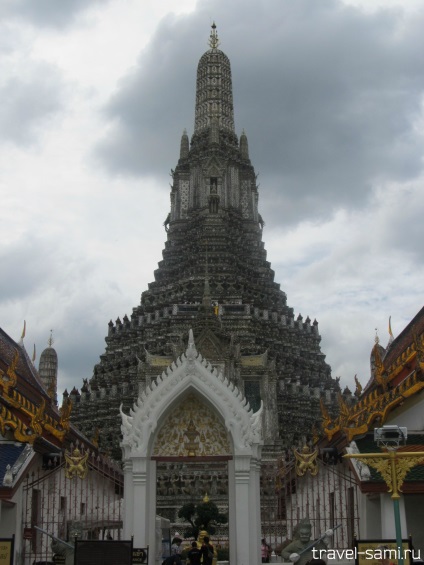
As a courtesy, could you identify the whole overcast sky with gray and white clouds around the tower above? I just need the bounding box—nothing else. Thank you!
[0,0,424,392]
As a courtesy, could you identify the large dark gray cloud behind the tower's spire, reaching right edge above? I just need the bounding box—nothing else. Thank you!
[94,0,424,222]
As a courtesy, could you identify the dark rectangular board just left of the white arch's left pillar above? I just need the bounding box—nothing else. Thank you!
[74,539,133,565]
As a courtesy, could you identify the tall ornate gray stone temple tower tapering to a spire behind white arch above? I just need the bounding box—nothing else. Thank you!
[70,25,339,528]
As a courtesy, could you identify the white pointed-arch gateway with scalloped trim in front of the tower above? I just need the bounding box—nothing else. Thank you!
[121,330,263,565]
